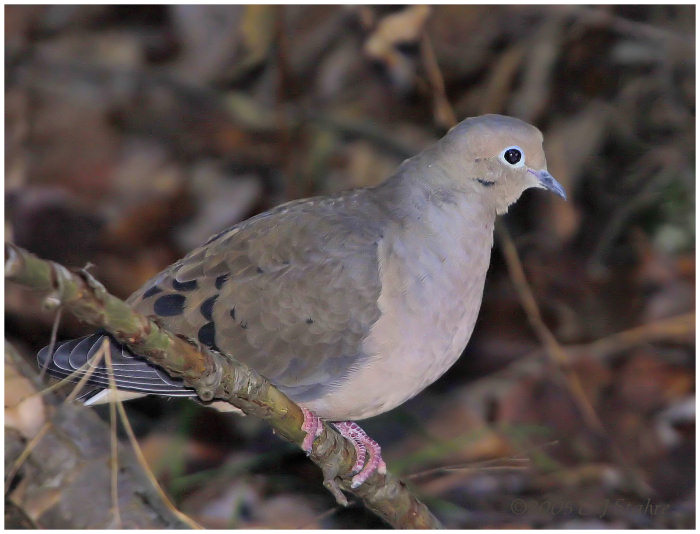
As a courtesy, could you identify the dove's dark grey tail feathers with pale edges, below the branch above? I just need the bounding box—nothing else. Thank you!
[37,332,197,397]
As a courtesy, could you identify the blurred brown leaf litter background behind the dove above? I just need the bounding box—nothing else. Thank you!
[5,5,695,528]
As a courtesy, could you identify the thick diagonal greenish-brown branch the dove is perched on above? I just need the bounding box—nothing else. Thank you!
[5,243,441,528]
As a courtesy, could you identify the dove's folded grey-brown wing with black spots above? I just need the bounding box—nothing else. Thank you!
[129,190,385,401]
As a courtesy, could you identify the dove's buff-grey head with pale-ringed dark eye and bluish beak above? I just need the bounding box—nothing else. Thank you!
[434,115,566,215]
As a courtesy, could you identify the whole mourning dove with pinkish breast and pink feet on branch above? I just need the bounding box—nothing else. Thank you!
[39,115,566,486]
